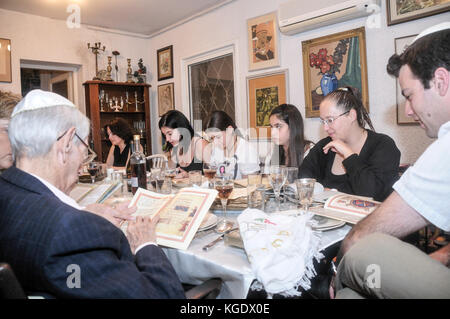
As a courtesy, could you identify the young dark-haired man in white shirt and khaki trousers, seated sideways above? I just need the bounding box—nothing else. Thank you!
[330,22,450,298]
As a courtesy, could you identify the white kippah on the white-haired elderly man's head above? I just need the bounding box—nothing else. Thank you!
[11,90,75,118]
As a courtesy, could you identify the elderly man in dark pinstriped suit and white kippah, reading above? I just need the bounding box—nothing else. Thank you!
[0,90,185,298]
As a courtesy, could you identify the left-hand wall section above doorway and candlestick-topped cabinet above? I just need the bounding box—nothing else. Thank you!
[0,9,150,111]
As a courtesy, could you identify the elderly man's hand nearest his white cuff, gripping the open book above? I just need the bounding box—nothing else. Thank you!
[127,215,159,253]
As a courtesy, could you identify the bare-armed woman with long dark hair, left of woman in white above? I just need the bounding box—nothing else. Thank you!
[158,110,209,178]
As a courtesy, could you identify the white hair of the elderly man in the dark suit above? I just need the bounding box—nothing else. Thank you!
[8,105,90,160]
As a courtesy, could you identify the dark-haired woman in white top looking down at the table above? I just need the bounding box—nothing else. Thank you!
[206,111,259,179]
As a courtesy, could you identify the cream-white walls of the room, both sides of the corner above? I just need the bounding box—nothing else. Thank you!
[0,0,450,162]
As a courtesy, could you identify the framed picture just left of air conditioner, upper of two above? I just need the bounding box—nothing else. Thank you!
[247,12,280,71]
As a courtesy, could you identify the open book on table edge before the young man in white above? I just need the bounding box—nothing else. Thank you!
[310,193,381,224]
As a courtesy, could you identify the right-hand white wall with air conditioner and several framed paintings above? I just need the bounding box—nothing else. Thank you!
[150,0,450,163]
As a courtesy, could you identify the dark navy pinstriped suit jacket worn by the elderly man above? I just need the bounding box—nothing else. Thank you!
[0,167,185,298]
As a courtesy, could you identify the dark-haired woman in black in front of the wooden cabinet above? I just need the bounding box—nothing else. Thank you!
[105,118,138,169]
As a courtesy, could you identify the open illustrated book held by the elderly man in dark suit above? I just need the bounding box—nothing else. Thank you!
[121,188,218,250]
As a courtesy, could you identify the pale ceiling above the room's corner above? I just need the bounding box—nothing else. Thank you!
[0,0,233,37]
